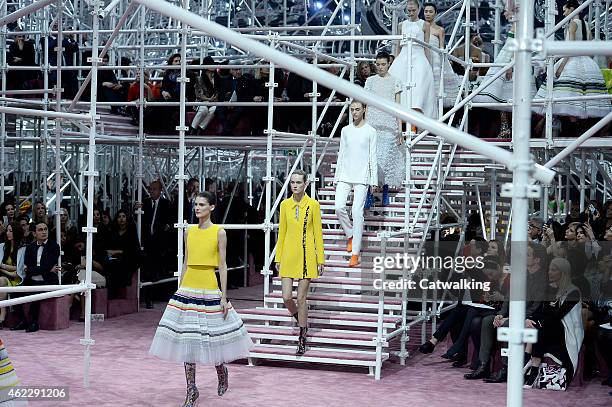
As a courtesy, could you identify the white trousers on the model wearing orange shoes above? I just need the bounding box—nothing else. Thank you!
[334,181,368,254]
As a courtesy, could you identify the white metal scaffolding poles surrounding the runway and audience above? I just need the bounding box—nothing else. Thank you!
[0,0,612,407]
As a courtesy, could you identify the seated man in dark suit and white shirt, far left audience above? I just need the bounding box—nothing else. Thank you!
[12,222,61,332]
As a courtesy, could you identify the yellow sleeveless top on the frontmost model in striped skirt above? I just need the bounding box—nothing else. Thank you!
[187,225,220,267]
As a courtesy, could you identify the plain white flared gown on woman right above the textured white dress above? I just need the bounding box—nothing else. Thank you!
[389,20,438,118]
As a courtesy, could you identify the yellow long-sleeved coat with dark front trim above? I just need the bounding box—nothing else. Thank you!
[275,194,325,278]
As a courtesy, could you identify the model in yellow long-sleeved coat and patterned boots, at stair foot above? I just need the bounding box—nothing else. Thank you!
[275,170,325,356]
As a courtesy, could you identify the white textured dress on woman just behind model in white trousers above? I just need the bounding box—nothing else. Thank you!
[364,74,406,188]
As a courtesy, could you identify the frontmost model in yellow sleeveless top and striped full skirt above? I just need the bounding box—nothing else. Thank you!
[149,192,253,407]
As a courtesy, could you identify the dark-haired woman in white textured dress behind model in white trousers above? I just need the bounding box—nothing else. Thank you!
[365,52,406,209]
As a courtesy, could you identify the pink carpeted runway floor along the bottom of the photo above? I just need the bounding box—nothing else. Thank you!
[0,290,612,407]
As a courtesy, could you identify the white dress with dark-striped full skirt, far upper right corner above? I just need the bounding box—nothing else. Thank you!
[533,19,612,119]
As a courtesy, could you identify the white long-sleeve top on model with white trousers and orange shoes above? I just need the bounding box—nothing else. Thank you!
[334,123,378,185]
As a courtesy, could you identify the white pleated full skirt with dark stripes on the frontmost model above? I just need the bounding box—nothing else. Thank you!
[149,269,253,365]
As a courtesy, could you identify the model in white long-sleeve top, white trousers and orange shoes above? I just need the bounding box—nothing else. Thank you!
[334,101,378,267]
